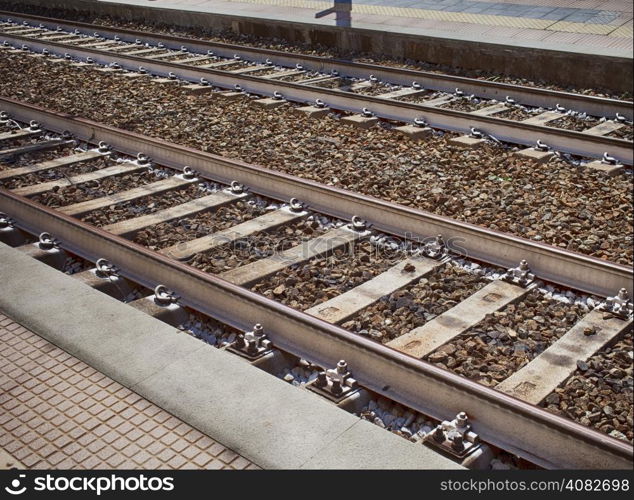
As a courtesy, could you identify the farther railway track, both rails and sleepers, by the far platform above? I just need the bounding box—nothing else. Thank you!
[0,13,632,165]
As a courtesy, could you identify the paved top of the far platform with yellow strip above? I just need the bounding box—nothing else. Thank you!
[98,0,633,57]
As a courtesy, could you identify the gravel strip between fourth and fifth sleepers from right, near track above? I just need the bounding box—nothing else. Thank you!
[189,220,325,274]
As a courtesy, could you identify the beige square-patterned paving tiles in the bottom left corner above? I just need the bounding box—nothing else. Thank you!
[0,313,258,470]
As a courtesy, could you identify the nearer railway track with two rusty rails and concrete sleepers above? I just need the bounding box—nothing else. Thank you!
[0,99,632,468]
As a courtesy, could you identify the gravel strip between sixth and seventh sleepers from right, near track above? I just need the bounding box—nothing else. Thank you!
[82,184,211,227]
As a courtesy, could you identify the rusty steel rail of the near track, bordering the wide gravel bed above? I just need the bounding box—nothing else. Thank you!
[0,98,634,296]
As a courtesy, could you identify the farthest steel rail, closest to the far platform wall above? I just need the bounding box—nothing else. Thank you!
[0,11,634,120]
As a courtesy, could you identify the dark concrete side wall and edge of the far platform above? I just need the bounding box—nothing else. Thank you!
[5,0,634,92]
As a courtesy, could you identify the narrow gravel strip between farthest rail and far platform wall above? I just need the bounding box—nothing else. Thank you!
[0,1,632,100]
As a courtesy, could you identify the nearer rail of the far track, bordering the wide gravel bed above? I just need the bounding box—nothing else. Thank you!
[1,35,634,165]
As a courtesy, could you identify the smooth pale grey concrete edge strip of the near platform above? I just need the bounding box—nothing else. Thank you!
[0,243,461,469]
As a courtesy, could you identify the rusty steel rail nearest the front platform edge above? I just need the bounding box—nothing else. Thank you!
[0,189,633,469]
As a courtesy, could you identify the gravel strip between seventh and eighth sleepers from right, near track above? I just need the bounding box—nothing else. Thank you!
[31,171,160,208]
